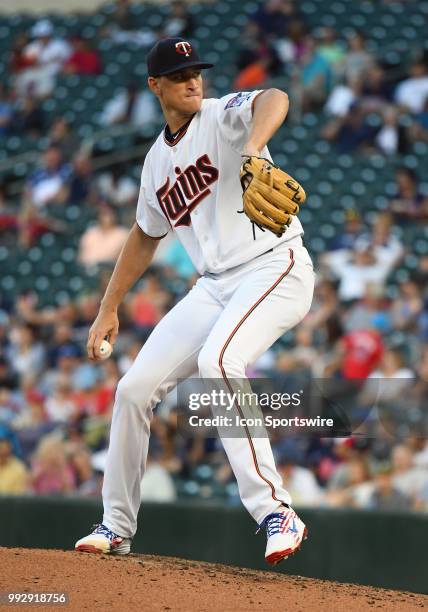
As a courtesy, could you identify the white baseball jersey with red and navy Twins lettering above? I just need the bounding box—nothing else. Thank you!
[136,91,303,274]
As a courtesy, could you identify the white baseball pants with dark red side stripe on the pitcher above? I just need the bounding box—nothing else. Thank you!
[103,238,314,537]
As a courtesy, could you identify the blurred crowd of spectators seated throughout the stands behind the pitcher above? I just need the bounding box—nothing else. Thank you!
[0,0,428,512]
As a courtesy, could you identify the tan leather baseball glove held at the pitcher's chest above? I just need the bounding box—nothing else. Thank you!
[240,156,306,237]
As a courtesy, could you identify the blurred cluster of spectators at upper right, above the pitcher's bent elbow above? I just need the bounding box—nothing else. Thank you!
[234,0,428,155]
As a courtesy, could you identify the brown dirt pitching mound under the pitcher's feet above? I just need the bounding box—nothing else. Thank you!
[0,548,428,612]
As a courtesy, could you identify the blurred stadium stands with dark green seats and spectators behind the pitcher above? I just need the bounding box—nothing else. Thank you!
[0,0,428,568]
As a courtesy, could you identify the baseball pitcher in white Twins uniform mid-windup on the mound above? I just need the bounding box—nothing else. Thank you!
[75,38,314,564]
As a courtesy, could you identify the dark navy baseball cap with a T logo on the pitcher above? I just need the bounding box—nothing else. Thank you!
[147,38,213,77]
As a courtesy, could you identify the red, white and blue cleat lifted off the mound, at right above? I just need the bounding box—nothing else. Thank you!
[260,507,308,565]
